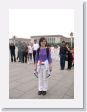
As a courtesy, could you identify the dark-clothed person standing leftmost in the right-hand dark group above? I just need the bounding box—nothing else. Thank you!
[59,41,67,70]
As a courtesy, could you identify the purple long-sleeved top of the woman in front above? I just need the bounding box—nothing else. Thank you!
[35,48,52,64]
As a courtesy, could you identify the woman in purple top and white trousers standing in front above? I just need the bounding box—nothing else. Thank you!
[35,37,52,95]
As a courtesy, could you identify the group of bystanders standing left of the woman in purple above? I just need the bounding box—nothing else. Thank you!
[9,40,39,64]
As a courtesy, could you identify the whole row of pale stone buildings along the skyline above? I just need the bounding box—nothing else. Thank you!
[9,35,74,44]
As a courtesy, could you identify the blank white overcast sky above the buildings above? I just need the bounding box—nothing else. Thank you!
[9,9,74,38]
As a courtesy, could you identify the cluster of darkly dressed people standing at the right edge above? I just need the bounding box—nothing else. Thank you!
[59,41,74,70]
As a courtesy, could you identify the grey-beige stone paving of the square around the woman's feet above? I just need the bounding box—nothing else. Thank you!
[9,60,74,99]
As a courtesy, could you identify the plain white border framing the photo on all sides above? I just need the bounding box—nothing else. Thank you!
[0,0,83,108]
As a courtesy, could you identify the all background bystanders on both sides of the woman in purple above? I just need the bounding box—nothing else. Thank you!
[9,40,74,70]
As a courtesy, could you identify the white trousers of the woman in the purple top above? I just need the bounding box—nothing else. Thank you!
[38,65,48,91]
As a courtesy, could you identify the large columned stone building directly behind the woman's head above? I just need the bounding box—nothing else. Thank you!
[31,35,74,44]
